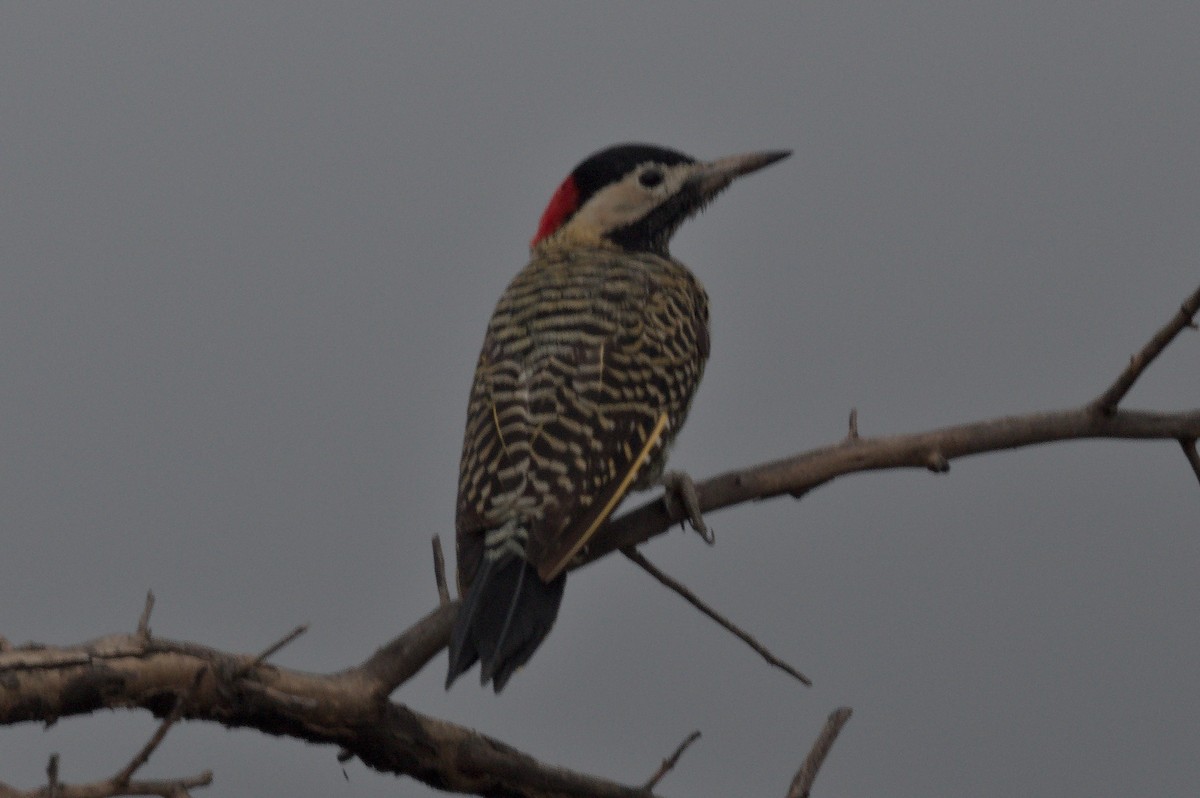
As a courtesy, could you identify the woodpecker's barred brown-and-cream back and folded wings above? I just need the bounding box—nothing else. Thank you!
[457,249,708,582]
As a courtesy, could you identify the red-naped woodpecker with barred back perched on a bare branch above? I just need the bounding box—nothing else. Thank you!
[446,144,790,692]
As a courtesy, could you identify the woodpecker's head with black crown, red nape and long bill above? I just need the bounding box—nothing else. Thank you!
[529,144,791,256]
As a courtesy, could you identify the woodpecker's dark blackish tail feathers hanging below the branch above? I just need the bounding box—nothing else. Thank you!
[446,556,566,692]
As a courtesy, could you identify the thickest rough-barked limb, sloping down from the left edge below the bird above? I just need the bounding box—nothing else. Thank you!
[0,633,648,798]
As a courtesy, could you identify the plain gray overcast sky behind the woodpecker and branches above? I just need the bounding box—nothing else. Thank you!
[0,0,1200,797]
